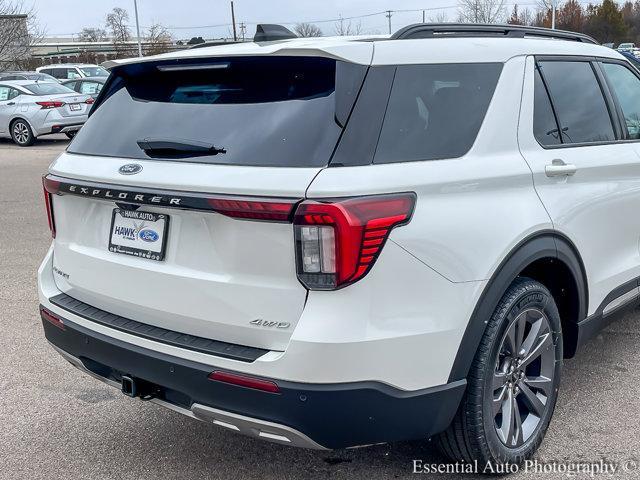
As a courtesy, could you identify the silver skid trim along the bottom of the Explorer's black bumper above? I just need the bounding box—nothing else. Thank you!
[49,342,327,450]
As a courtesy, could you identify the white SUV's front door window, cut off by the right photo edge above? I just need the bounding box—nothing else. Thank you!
[601,63,640,140]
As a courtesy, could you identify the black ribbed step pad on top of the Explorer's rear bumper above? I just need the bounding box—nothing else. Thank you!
[49,293,268,362]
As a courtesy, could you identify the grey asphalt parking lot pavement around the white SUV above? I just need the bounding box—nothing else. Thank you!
[0,137,640,480]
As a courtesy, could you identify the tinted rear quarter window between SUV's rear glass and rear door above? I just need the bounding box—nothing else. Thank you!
[374,63,502,163]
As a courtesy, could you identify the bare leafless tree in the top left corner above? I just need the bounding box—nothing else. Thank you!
[0,0,43,71]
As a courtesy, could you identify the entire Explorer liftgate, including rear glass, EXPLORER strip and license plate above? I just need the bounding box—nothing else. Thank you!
[45,53,366,350]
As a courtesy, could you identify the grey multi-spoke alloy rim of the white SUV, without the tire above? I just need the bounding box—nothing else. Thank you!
[492,309,557,448]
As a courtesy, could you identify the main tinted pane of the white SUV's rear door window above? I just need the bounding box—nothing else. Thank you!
[540,61,615,143]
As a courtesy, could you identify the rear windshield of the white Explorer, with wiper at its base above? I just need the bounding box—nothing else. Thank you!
[69,57,352,167]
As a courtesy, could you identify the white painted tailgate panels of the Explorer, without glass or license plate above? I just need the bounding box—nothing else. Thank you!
[50,154,320,350]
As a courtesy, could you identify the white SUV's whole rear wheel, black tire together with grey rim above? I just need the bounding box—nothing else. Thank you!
[437,278,563,473]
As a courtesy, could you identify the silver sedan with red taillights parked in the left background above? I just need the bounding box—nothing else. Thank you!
[0,80,94,147]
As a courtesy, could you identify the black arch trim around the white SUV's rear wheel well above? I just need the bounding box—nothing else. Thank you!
[449,230,589,382]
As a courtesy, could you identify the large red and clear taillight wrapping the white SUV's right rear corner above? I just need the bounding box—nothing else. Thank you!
[294,193,416,290]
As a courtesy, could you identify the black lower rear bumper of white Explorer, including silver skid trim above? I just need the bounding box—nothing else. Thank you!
[43,308,466,449]
